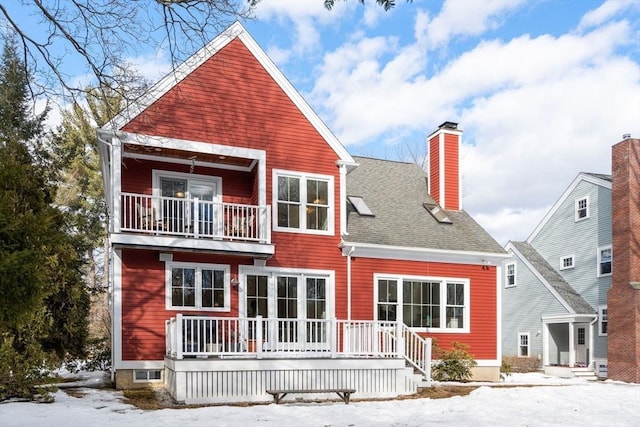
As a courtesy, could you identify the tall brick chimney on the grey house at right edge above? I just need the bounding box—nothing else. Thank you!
[607,135,640,383]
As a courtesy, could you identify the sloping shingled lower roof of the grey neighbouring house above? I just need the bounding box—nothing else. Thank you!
[511,242,595,314]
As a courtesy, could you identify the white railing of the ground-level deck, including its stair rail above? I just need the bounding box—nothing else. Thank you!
[166,314,431,378]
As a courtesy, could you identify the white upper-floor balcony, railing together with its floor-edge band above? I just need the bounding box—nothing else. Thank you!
[113,193,273,255]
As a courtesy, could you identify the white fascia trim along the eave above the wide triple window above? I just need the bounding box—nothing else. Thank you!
[340,241,509,266]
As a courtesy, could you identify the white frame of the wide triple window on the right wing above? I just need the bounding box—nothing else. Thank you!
[373,273,471,334]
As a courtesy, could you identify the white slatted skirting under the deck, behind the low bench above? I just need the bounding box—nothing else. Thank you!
[164,357,417,404]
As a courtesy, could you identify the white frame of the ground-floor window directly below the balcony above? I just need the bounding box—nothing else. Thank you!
[165,261,231,312]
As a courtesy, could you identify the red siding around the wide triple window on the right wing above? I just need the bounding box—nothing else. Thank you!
[348,257,497,359]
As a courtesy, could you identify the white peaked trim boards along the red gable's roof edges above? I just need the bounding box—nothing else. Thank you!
[104,21,353,163]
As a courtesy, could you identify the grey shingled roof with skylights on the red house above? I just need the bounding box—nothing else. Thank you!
[345,157,505,254]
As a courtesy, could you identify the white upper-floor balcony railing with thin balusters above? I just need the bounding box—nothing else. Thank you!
[120,193,271,243]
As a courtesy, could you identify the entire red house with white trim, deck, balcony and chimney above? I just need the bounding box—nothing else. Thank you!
[98,23,505,403]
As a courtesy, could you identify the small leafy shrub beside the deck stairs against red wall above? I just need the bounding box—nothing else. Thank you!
[431,340,477,381]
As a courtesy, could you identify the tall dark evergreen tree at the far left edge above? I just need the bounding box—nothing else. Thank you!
[0,36,89,400]
